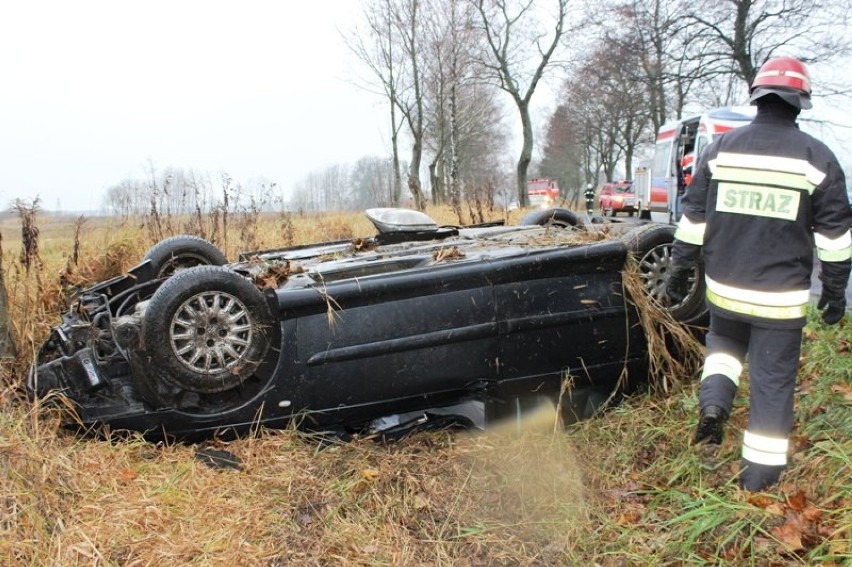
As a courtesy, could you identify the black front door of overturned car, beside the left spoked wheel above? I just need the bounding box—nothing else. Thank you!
[282,261,498,422]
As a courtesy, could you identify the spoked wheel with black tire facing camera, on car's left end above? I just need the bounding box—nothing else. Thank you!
[142,266,275,394]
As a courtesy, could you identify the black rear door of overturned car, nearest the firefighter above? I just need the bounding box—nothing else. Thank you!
[494,242,640,397]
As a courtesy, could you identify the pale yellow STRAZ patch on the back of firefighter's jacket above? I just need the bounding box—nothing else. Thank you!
[716,182,802,221]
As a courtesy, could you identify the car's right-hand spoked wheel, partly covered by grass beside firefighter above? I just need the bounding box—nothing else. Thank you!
[623,224,707,323]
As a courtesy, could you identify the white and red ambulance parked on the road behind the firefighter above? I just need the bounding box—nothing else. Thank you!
[639,106,757,224]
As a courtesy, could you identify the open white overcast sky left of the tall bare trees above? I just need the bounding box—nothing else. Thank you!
[0,0,388,211]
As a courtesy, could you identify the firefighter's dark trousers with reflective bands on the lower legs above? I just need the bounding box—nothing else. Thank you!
[698,313,802,491]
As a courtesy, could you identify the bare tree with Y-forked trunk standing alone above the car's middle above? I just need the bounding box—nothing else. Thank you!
[473,0,568,206]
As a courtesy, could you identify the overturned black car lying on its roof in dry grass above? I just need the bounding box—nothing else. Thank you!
[28,209,705,440]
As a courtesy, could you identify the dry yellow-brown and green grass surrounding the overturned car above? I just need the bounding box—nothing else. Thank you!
[0,209,852,566]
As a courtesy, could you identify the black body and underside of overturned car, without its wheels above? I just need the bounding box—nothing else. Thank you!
[30,213,664,440]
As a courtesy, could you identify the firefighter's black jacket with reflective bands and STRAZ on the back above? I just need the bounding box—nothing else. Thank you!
[674,105,852,328]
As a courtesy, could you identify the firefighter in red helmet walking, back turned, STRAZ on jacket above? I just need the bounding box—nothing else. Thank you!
[666,57,852,491]
